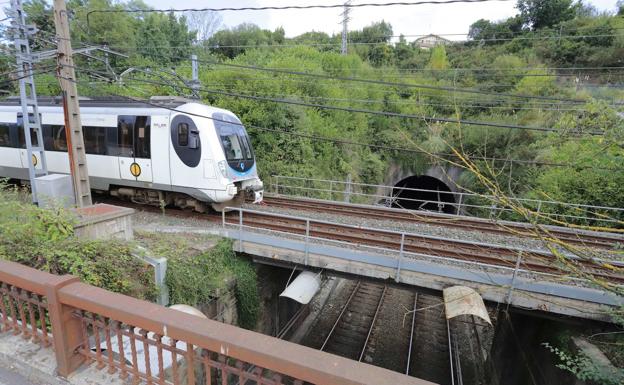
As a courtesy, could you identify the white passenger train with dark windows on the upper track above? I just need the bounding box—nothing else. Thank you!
[0,97,263,211]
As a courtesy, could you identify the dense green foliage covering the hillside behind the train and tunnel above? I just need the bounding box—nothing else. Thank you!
[0,0,624,222]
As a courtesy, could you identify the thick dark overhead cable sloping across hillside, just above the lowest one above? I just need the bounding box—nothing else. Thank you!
[70,63,603,135]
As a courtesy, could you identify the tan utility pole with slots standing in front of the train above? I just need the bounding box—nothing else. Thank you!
[54,0,92,207]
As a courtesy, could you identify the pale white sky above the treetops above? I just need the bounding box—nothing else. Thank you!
[0,0,617,40]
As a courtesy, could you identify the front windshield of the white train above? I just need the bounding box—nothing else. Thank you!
[212,113,254,172]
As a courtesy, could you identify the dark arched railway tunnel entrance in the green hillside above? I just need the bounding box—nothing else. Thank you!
[391,175,457,214]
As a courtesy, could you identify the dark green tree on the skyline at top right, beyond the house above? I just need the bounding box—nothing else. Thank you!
[516,0,579,30]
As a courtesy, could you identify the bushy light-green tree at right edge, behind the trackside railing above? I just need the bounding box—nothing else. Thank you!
[532,101,624,224]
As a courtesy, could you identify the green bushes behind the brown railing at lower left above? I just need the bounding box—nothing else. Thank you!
[0,182,155,300]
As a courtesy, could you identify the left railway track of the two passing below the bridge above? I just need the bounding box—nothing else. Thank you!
[320,281,387,361]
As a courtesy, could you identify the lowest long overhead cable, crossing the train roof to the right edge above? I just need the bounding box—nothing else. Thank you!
[50,74,624,171]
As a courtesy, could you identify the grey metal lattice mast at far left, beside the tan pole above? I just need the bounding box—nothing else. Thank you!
[11,0,48,203]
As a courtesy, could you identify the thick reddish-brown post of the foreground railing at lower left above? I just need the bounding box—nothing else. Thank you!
[46,275,84,378]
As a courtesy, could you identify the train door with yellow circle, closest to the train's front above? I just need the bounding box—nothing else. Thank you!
[117,115,153,182]
